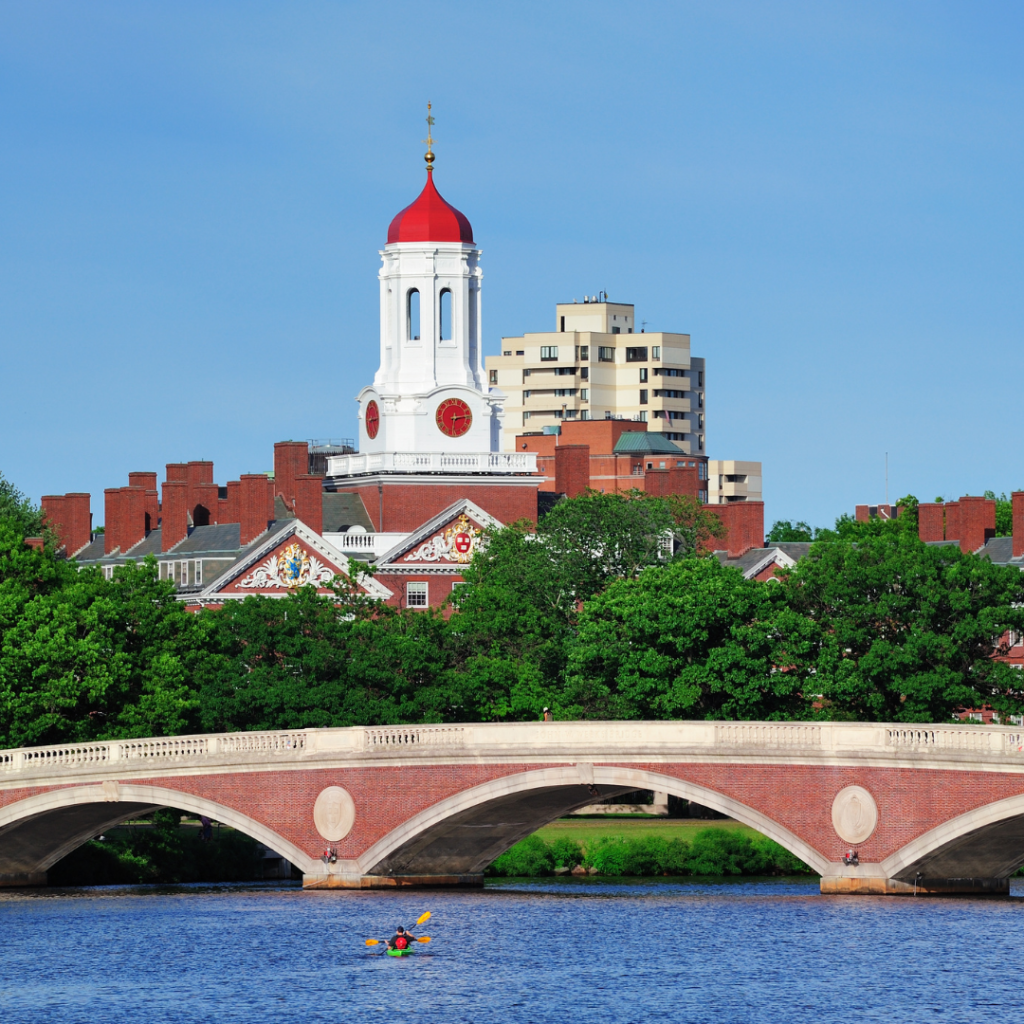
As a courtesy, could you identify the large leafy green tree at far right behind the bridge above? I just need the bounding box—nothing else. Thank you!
[779,521,1024,722]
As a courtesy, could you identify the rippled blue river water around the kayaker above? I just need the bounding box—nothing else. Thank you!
[0,880,1024,1024]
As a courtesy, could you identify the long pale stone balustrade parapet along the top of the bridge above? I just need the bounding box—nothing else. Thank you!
[0,722,1024,783]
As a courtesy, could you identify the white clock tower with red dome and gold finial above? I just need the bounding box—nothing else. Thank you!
[358,117,505,455]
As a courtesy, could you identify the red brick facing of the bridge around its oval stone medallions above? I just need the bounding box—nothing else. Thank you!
[6,761,1024,863]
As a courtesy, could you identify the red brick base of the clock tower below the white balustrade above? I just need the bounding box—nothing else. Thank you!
[339,476,538,534]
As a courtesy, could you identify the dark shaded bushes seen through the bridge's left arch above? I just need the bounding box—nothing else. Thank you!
[48,808,263,886]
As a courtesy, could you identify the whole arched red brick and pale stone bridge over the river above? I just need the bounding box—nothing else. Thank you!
[0,722,1024,894]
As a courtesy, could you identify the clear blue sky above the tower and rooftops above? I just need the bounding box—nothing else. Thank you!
[0,8,1024,524]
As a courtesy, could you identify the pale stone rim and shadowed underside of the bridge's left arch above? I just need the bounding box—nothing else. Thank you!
[0,783,323,886]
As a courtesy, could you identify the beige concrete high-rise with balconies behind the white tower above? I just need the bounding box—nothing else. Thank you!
[486,296,707,455]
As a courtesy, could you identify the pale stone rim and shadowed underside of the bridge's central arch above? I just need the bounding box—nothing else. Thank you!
[355,763,828,878]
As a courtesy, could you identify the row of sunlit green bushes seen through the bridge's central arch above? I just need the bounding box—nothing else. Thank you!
[486,828,813,878]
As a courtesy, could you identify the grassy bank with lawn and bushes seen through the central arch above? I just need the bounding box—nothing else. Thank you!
[487,818,813,878]
